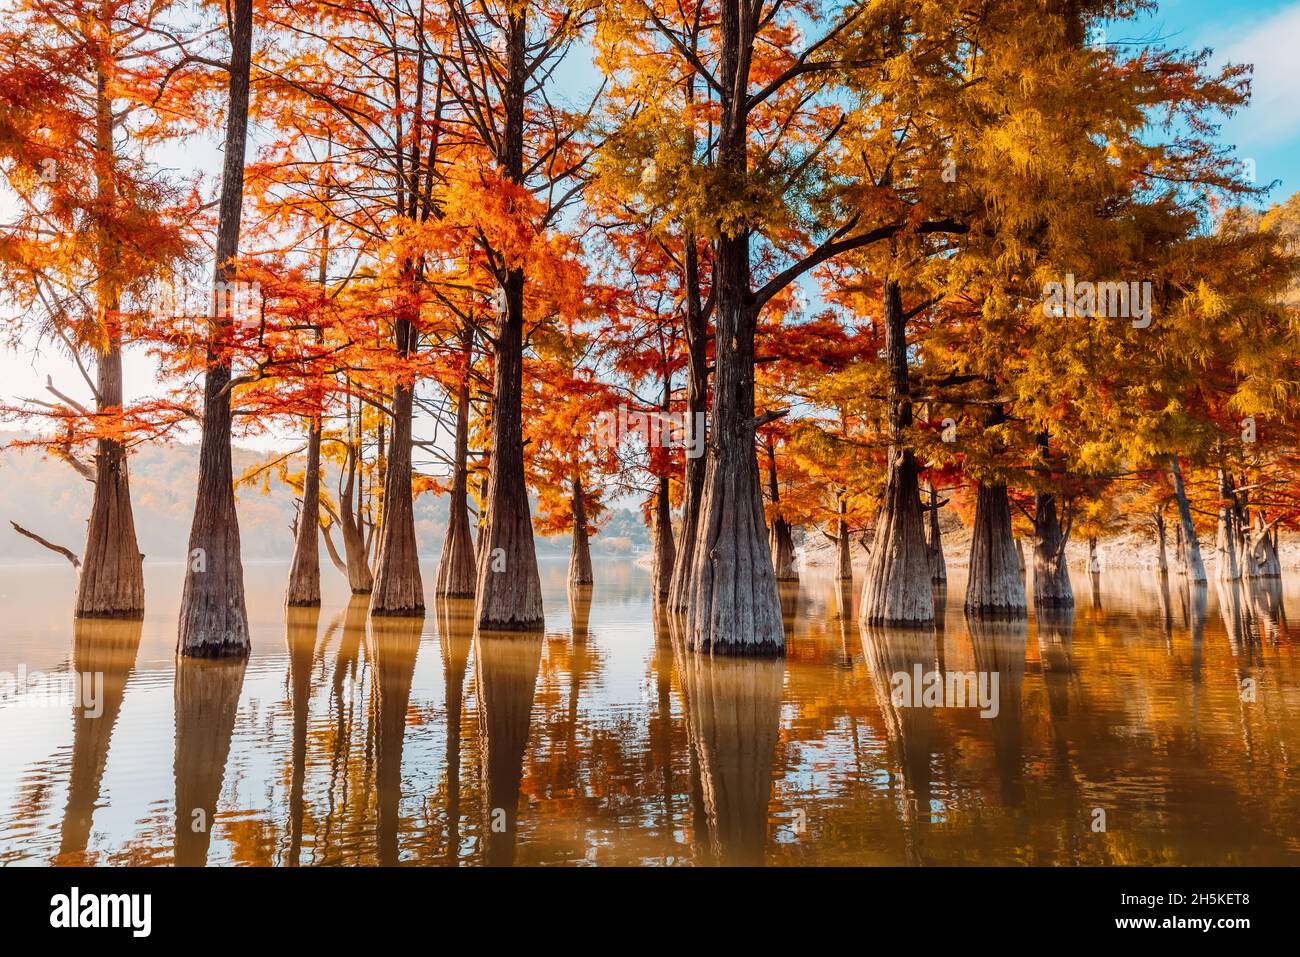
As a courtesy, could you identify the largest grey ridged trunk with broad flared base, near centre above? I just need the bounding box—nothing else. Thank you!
[686,227,785,654]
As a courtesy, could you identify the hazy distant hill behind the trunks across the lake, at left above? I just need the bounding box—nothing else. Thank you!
[0,432,650,563]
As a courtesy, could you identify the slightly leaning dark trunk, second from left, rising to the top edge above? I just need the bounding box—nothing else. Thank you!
[177,0,252,657]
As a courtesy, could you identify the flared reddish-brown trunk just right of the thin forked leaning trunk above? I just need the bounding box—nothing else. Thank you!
[371,315,424,618]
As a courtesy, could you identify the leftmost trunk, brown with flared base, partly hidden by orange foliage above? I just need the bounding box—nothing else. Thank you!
[75,46,144,618]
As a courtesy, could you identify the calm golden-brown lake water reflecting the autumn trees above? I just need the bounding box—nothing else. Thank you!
[0,559,1300,866]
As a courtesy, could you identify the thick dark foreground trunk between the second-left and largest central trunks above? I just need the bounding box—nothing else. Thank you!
[477,8,545,631]
